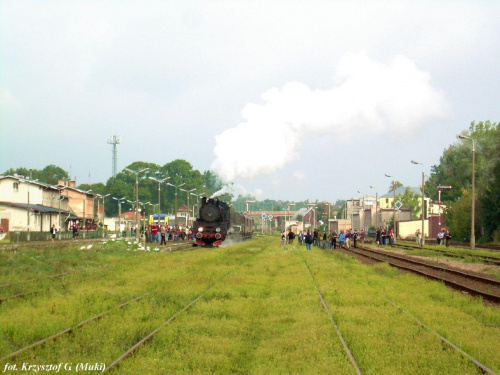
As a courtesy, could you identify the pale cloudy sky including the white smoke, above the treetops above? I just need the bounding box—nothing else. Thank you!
[0,0,500,202]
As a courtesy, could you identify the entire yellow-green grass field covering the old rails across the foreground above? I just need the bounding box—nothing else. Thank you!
[0,237,500,374]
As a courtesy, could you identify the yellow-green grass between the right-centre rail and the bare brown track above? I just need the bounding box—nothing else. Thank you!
[304,245,500,374]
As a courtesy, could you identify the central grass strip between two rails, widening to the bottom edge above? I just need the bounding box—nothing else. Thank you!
[120,239,354,374]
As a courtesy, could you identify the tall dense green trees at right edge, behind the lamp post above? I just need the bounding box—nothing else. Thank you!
[425,121,500,241]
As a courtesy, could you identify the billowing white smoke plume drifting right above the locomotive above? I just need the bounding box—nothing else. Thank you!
[212,52,448,182]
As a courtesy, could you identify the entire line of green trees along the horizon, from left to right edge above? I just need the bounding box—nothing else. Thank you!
[4,121,500,242]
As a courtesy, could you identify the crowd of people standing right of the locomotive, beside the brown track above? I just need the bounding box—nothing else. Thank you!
[281,229,365,250]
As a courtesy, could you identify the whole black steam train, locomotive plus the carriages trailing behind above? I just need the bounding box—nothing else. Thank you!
[193,198,254,247]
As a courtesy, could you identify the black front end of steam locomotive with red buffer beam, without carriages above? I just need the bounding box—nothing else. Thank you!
[193,198,230,246]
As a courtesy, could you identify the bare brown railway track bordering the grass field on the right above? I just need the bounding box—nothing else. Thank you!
[342,247,500,303]
